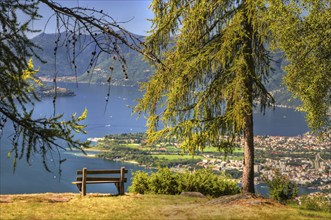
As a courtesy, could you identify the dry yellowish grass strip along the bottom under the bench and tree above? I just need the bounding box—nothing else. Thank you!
[0,193,331,220]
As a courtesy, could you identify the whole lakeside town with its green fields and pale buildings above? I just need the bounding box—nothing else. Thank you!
[89,133,331,193]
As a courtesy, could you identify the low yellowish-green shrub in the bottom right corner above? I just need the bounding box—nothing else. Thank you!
[299,193,331,212]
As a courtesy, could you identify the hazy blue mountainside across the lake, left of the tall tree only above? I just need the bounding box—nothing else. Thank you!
[32,33,153,85]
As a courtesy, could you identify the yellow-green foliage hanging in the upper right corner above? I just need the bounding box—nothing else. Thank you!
[269,0,331,131]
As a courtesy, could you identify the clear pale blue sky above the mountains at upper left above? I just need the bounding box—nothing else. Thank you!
[29,0,153,35]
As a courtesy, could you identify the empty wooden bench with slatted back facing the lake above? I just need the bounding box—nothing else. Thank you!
[72,167,128,196]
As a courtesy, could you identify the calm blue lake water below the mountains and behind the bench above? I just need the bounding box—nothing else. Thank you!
[0,83,308,194]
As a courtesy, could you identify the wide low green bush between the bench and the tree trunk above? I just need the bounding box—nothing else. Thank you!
[129,168,240,197]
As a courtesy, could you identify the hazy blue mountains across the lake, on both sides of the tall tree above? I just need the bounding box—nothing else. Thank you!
[32,33,300,107]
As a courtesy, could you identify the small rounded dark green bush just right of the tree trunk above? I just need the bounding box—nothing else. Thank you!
[262,169,298,203]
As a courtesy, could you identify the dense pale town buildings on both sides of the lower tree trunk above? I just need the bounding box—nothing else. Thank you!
[193,134,331,189]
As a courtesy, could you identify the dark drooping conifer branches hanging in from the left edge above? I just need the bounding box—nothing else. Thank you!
[0,0,161,170]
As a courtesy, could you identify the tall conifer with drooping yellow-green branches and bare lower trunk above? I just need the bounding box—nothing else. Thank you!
[136,0,274,193]
